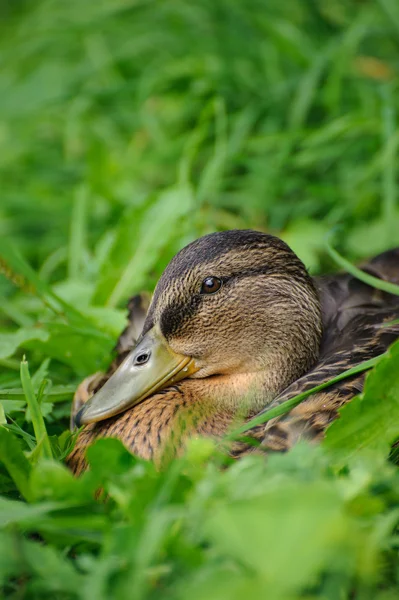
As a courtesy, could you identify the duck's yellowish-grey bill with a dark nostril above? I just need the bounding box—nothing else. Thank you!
[75,326,198,427]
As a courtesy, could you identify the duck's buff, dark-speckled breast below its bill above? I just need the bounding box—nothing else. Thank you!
[68,377,242,474]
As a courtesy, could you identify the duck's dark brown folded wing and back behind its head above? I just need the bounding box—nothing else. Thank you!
[244,248,399,453]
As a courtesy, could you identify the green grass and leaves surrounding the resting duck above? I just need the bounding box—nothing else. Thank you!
[0,0,399,600]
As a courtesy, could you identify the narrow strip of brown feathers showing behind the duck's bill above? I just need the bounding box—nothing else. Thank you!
[70,292,151,429]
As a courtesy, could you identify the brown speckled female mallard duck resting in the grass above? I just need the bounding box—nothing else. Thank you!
[69,230,399,472]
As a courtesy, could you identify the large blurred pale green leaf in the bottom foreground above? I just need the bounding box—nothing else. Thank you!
[203,480,351,599]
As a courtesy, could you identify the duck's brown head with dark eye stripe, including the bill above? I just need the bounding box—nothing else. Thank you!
[77,230,322,424]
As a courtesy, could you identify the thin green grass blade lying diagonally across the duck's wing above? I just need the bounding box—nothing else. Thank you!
[225,353,385,440]
